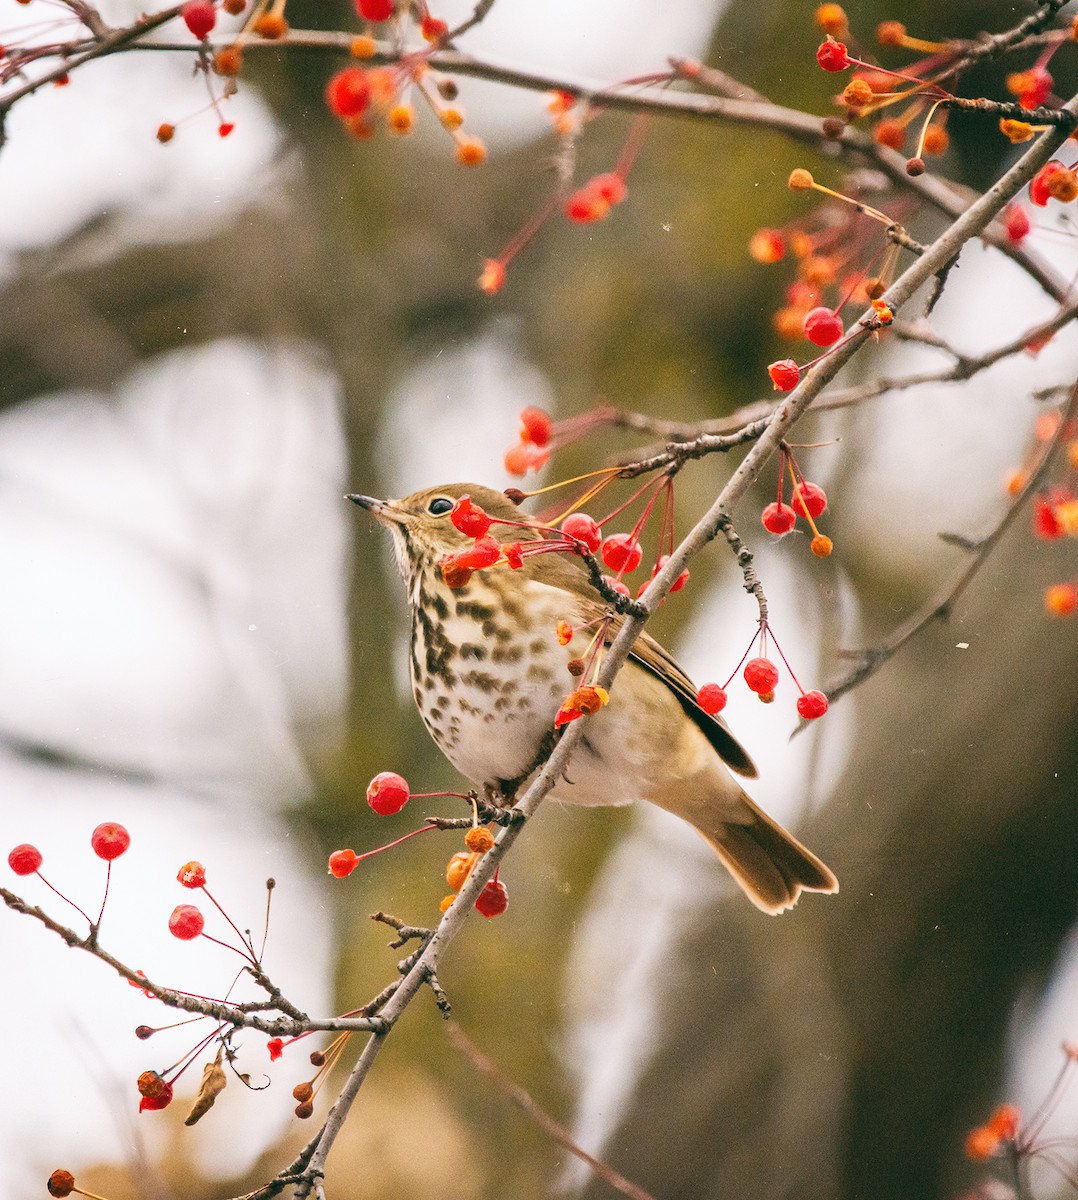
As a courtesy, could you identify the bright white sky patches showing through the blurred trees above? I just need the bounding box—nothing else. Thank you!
[0,0,1078,1196]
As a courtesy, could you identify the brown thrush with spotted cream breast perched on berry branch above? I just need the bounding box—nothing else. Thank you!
[349,484,838,913]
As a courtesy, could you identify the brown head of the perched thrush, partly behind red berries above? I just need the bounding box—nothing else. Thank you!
[347,484,539,580]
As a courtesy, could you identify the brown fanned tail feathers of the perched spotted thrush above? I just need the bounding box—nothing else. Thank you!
[693,796,838,916]
